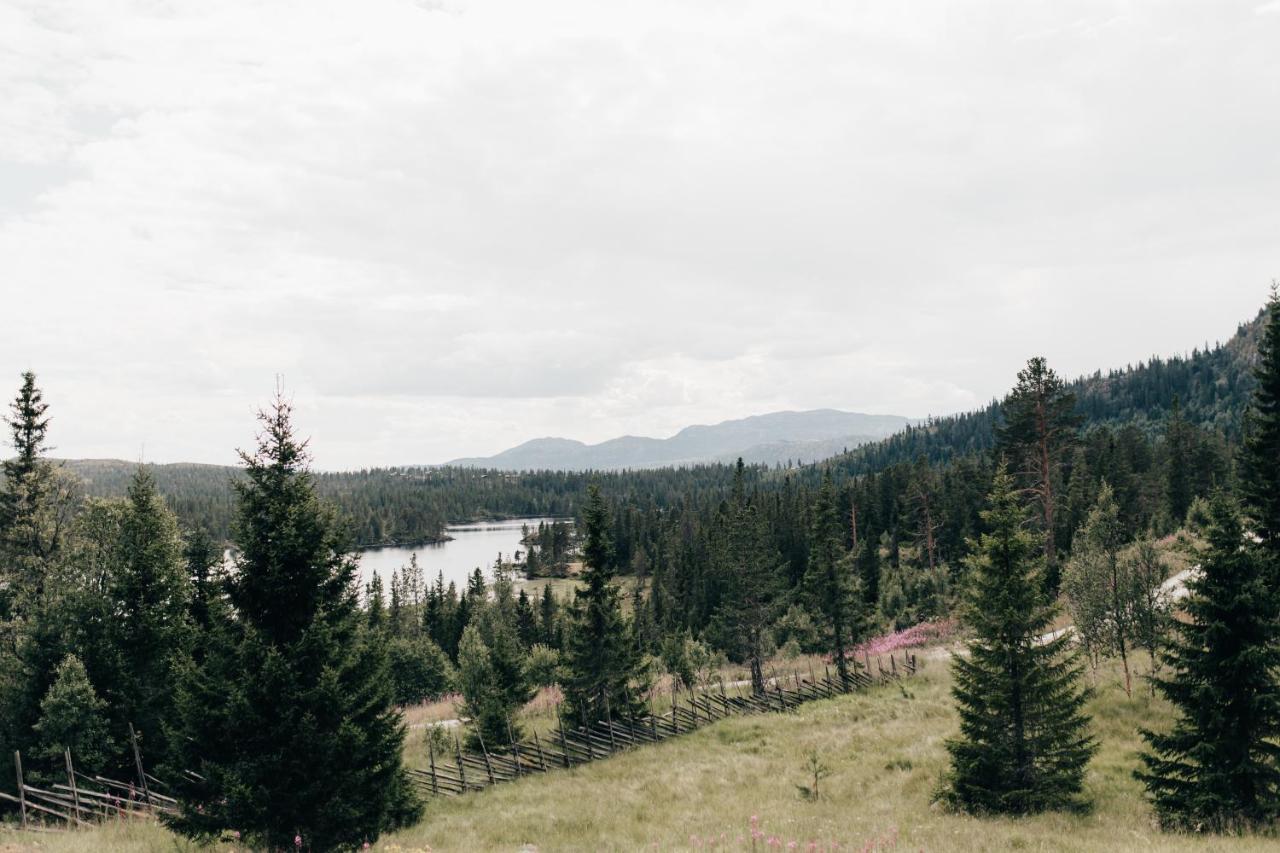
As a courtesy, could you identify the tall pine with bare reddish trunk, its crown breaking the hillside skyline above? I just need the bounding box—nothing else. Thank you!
[997,357,1079,593]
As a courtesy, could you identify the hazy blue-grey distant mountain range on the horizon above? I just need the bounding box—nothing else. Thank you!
[448,409,911,471]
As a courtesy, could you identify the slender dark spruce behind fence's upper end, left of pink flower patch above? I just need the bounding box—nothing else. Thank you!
[804,471,865,679]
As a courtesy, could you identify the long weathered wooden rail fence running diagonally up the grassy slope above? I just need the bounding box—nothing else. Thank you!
[408,653,919,797]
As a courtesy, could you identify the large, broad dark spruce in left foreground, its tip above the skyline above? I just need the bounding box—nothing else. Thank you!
[168,396,421,850]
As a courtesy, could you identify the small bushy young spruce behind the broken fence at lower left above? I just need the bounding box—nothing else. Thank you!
[29,654,114,780]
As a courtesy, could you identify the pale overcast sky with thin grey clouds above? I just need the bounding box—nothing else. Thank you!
[0,0,1280,469]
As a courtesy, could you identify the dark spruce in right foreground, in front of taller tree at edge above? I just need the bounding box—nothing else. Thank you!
[1137,494,1280,833]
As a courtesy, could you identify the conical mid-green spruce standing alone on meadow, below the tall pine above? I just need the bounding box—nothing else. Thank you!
[943,467,1097,815]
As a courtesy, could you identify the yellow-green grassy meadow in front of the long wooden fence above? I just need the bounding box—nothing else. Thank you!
[0,648,1280,853]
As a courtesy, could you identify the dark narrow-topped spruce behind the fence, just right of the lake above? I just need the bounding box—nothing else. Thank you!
[563,483,643,725]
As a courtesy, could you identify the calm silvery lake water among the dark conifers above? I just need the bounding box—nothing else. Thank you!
[360,519,563,589]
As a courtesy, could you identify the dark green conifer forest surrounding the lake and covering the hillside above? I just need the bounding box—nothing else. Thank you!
[0,298,1280,850]
